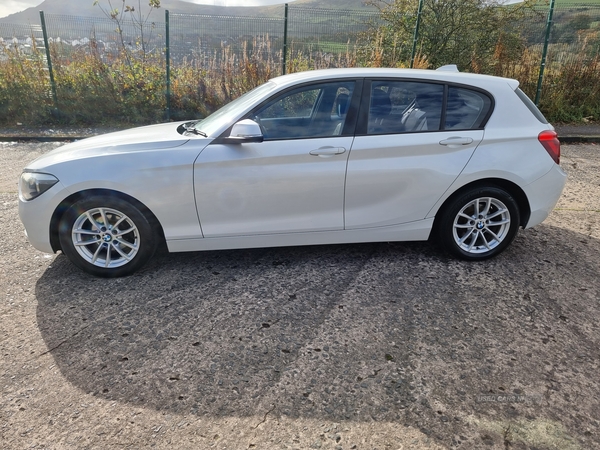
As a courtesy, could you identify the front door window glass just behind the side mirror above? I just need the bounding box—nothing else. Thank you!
[251,81,355,140]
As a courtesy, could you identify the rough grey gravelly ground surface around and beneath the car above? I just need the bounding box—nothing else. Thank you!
[0,143,600,450]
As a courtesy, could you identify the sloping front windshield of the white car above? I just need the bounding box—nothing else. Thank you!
[194,81,277,136]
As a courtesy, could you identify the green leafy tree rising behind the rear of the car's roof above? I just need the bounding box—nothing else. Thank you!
[360,0,531,72]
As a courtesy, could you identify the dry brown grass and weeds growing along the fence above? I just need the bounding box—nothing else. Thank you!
[0,32,600,124]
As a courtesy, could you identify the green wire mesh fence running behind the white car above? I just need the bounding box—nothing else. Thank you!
[0,5,600,121]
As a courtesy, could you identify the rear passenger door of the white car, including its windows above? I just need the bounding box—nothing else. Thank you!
[345,79,492,229]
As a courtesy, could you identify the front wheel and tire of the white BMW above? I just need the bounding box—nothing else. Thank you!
[59,195,159,278]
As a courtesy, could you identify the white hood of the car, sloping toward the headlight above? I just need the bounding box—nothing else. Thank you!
[27,121,195,170]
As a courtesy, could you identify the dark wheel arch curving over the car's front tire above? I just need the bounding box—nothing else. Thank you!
[50,189,166,253]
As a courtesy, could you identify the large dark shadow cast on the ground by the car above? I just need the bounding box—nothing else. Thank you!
[36,225,600,449]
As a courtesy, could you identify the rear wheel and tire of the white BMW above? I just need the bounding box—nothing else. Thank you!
[436,187,520,261]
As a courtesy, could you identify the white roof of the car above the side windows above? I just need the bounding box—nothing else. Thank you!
[271,67,519,90]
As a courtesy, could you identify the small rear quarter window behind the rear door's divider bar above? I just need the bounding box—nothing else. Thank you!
[444,86,492,130]
